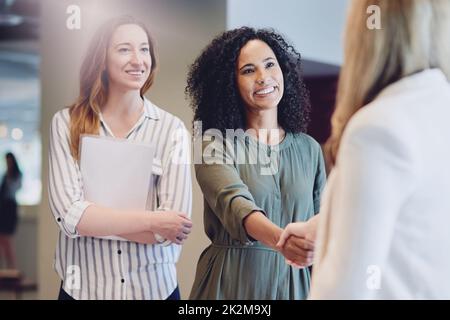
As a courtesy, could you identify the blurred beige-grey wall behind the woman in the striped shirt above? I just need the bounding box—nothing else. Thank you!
[38,0,226,299]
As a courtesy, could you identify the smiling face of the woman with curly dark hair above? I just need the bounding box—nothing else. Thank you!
[237,40,284,110]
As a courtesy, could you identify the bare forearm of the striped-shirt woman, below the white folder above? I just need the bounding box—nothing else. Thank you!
[77,205,152,237]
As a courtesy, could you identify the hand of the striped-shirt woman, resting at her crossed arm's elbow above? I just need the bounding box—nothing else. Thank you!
[150,211,192,244]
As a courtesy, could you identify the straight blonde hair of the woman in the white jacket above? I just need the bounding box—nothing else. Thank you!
[326,0,450,163]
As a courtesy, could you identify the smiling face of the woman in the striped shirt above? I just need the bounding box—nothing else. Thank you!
[106,24,152,90]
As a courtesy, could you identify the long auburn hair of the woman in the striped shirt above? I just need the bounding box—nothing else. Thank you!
[69,16,157,160]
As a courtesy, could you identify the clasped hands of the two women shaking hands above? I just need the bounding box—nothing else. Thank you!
[276,215,318,268]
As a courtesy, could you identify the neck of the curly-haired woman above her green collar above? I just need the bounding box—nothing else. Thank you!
[246,108,284,145]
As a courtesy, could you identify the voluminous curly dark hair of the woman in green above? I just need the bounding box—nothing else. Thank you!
[185,27,310,133]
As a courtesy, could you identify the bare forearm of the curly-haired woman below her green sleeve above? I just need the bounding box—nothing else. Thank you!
[244,211,283,250]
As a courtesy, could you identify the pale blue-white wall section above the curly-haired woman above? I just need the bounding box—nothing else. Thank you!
[227,0,349,65]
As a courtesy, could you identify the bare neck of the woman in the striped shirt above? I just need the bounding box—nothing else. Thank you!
[101,84,143,116]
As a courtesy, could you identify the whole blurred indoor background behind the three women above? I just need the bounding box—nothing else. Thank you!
[0,0,348,299]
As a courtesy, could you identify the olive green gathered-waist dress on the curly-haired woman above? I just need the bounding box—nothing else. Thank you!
[190,133,326,300]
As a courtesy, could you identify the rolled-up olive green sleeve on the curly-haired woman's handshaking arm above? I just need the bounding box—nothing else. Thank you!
[195,142,265,244]
